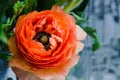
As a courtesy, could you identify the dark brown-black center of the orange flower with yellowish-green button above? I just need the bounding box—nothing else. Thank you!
[33,32,51,51]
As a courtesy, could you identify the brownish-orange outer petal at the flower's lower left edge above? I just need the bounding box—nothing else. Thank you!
[9,37,31,70]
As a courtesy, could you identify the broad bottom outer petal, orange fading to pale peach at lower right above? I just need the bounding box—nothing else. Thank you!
[35,55,79,80]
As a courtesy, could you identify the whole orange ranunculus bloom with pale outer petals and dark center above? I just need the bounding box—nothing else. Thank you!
[9,6,86,80]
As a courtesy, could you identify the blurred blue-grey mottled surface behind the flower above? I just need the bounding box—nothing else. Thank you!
[0,0,120,80]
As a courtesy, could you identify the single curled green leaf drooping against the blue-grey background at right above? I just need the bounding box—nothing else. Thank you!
[83,27,101,51]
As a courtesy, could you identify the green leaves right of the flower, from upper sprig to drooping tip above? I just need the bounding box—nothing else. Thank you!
[70,12,101,51]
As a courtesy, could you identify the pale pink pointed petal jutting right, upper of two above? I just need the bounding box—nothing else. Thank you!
[76,25,87,40]
